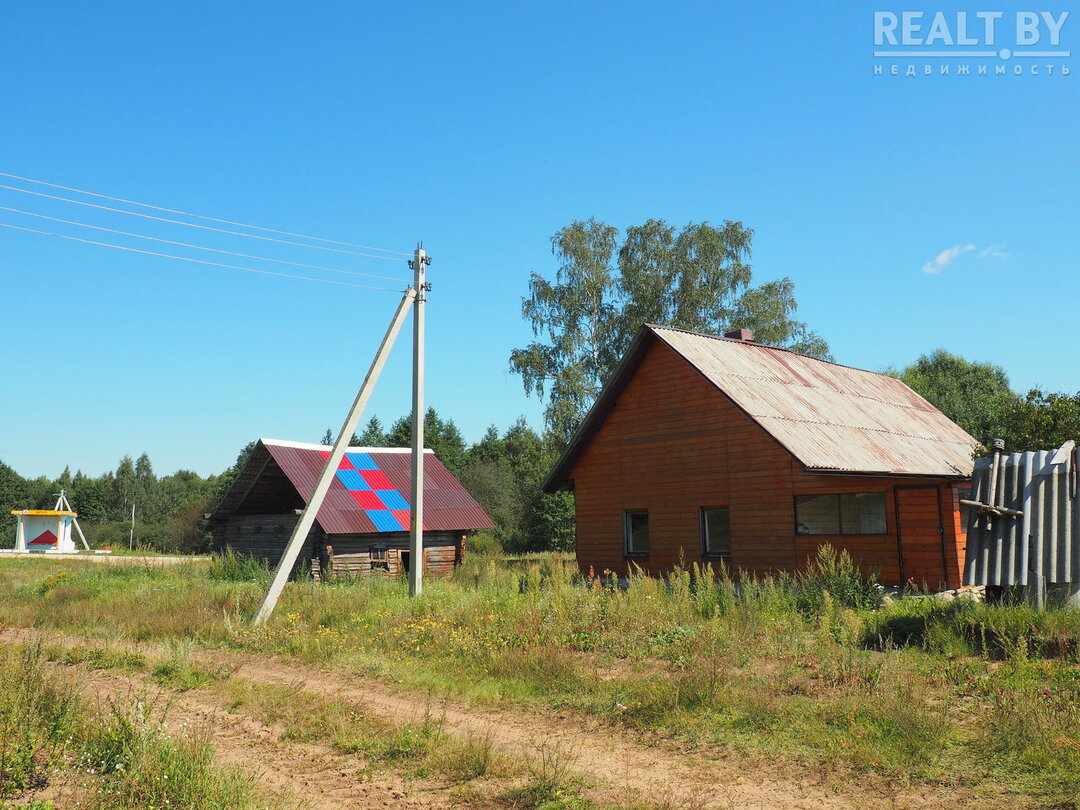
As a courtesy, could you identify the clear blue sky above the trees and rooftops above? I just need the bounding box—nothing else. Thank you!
[0,1,1080,475]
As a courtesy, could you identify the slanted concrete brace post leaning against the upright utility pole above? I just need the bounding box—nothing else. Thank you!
[252,287,416,625]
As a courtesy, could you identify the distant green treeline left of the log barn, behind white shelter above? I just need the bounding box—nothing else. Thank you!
[0,454,227,552]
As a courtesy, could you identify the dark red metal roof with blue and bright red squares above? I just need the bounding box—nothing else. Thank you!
[217,438,495,535]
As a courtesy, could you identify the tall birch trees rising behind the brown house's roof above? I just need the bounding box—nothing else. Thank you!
[510,219,829,442]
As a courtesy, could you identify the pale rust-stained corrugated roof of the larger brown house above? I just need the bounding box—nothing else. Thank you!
[544,324,978,491]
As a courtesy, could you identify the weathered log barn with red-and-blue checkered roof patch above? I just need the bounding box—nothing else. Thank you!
[210,438,494,577]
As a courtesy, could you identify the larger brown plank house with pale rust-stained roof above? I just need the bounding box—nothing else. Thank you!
[544,325,978,589]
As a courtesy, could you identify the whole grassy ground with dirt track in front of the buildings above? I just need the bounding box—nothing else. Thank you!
[0,553,1080,810]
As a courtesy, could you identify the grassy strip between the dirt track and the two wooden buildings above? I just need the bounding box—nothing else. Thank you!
[0,550,1080,807]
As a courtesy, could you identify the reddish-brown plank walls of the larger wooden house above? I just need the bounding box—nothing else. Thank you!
[570,341,963,586]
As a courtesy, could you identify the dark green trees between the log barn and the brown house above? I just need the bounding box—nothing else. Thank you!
[332,408,573,552]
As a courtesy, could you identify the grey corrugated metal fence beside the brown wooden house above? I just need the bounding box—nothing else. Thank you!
[964,447,1080,591]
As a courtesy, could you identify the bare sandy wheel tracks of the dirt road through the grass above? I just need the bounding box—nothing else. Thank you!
[0,629,1016,810]
